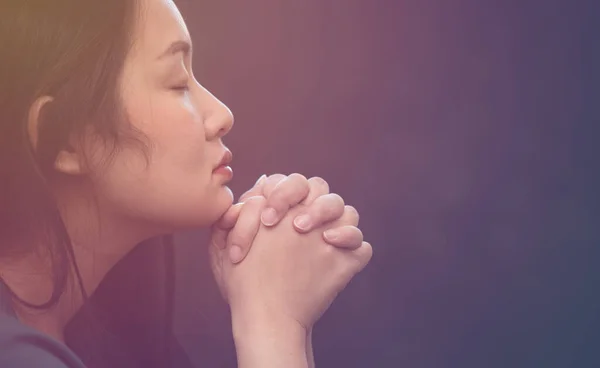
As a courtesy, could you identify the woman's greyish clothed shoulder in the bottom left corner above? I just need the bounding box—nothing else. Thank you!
[0,312,85,368]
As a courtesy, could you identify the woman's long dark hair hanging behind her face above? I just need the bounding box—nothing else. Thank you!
[0,0,182,366]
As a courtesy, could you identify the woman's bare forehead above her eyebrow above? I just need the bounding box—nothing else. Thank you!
[133,0,190,58]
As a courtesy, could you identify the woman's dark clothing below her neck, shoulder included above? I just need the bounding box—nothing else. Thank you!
[0,239,193,368]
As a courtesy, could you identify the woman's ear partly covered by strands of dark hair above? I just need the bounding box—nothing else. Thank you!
[27,96,86,175]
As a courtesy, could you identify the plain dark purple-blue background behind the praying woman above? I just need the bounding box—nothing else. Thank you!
[168,0,600,368]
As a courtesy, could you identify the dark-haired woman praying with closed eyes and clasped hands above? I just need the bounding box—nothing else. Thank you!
[0,0,371,368]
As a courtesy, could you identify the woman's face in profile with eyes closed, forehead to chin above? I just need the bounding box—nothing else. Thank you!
[89,0,233,231]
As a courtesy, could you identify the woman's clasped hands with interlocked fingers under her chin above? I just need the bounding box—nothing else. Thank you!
[210,174,372,330]
